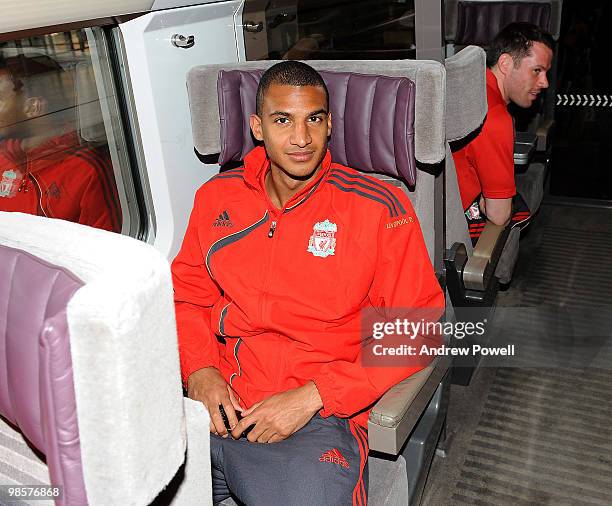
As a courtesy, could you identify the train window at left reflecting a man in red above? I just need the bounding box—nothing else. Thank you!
[0,27,139,235]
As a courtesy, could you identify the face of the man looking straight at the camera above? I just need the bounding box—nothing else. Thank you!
[251,84,331,180]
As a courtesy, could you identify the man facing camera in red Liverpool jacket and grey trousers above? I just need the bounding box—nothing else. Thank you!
[172,61,444,505]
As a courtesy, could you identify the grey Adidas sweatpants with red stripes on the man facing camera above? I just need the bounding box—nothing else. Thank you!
[210,415,368,506]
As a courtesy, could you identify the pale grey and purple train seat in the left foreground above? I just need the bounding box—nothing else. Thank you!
[0,212,212,505]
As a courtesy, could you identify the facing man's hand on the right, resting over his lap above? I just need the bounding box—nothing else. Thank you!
[232,381,323,443]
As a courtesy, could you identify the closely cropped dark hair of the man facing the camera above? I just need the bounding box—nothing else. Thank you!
[256,60,329,116]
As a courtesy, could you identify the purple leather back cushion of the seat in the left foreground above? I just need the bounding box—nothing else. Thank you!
[0,245,86,503]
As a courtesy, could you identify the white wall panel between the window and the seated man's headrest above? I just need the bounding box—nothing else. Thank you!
[120,0,242,258]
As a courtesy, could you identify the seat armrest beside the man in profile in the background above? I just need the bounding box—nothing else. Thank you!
[463,221,510,291]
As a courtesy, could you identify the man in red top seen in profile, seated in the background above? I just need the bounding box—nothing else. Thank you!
[453,23,554,244]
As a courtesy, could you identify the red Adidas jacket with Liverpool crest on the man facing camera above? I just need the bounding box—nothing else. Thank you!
[172,147,444,426]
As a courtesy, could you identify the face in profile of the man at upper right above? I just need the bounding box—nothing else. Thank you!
[504,42,553,108]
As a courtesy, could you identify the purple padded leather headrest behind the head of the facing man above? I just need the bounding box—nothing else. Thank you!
[217,70,416,186]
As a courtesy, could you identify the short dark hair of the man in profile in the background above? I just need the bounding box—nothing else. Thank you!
[487,22,555,68]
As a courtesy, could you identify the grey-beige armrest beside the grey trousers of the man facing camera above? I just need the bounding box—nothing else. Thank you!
[368,357,450,455]
